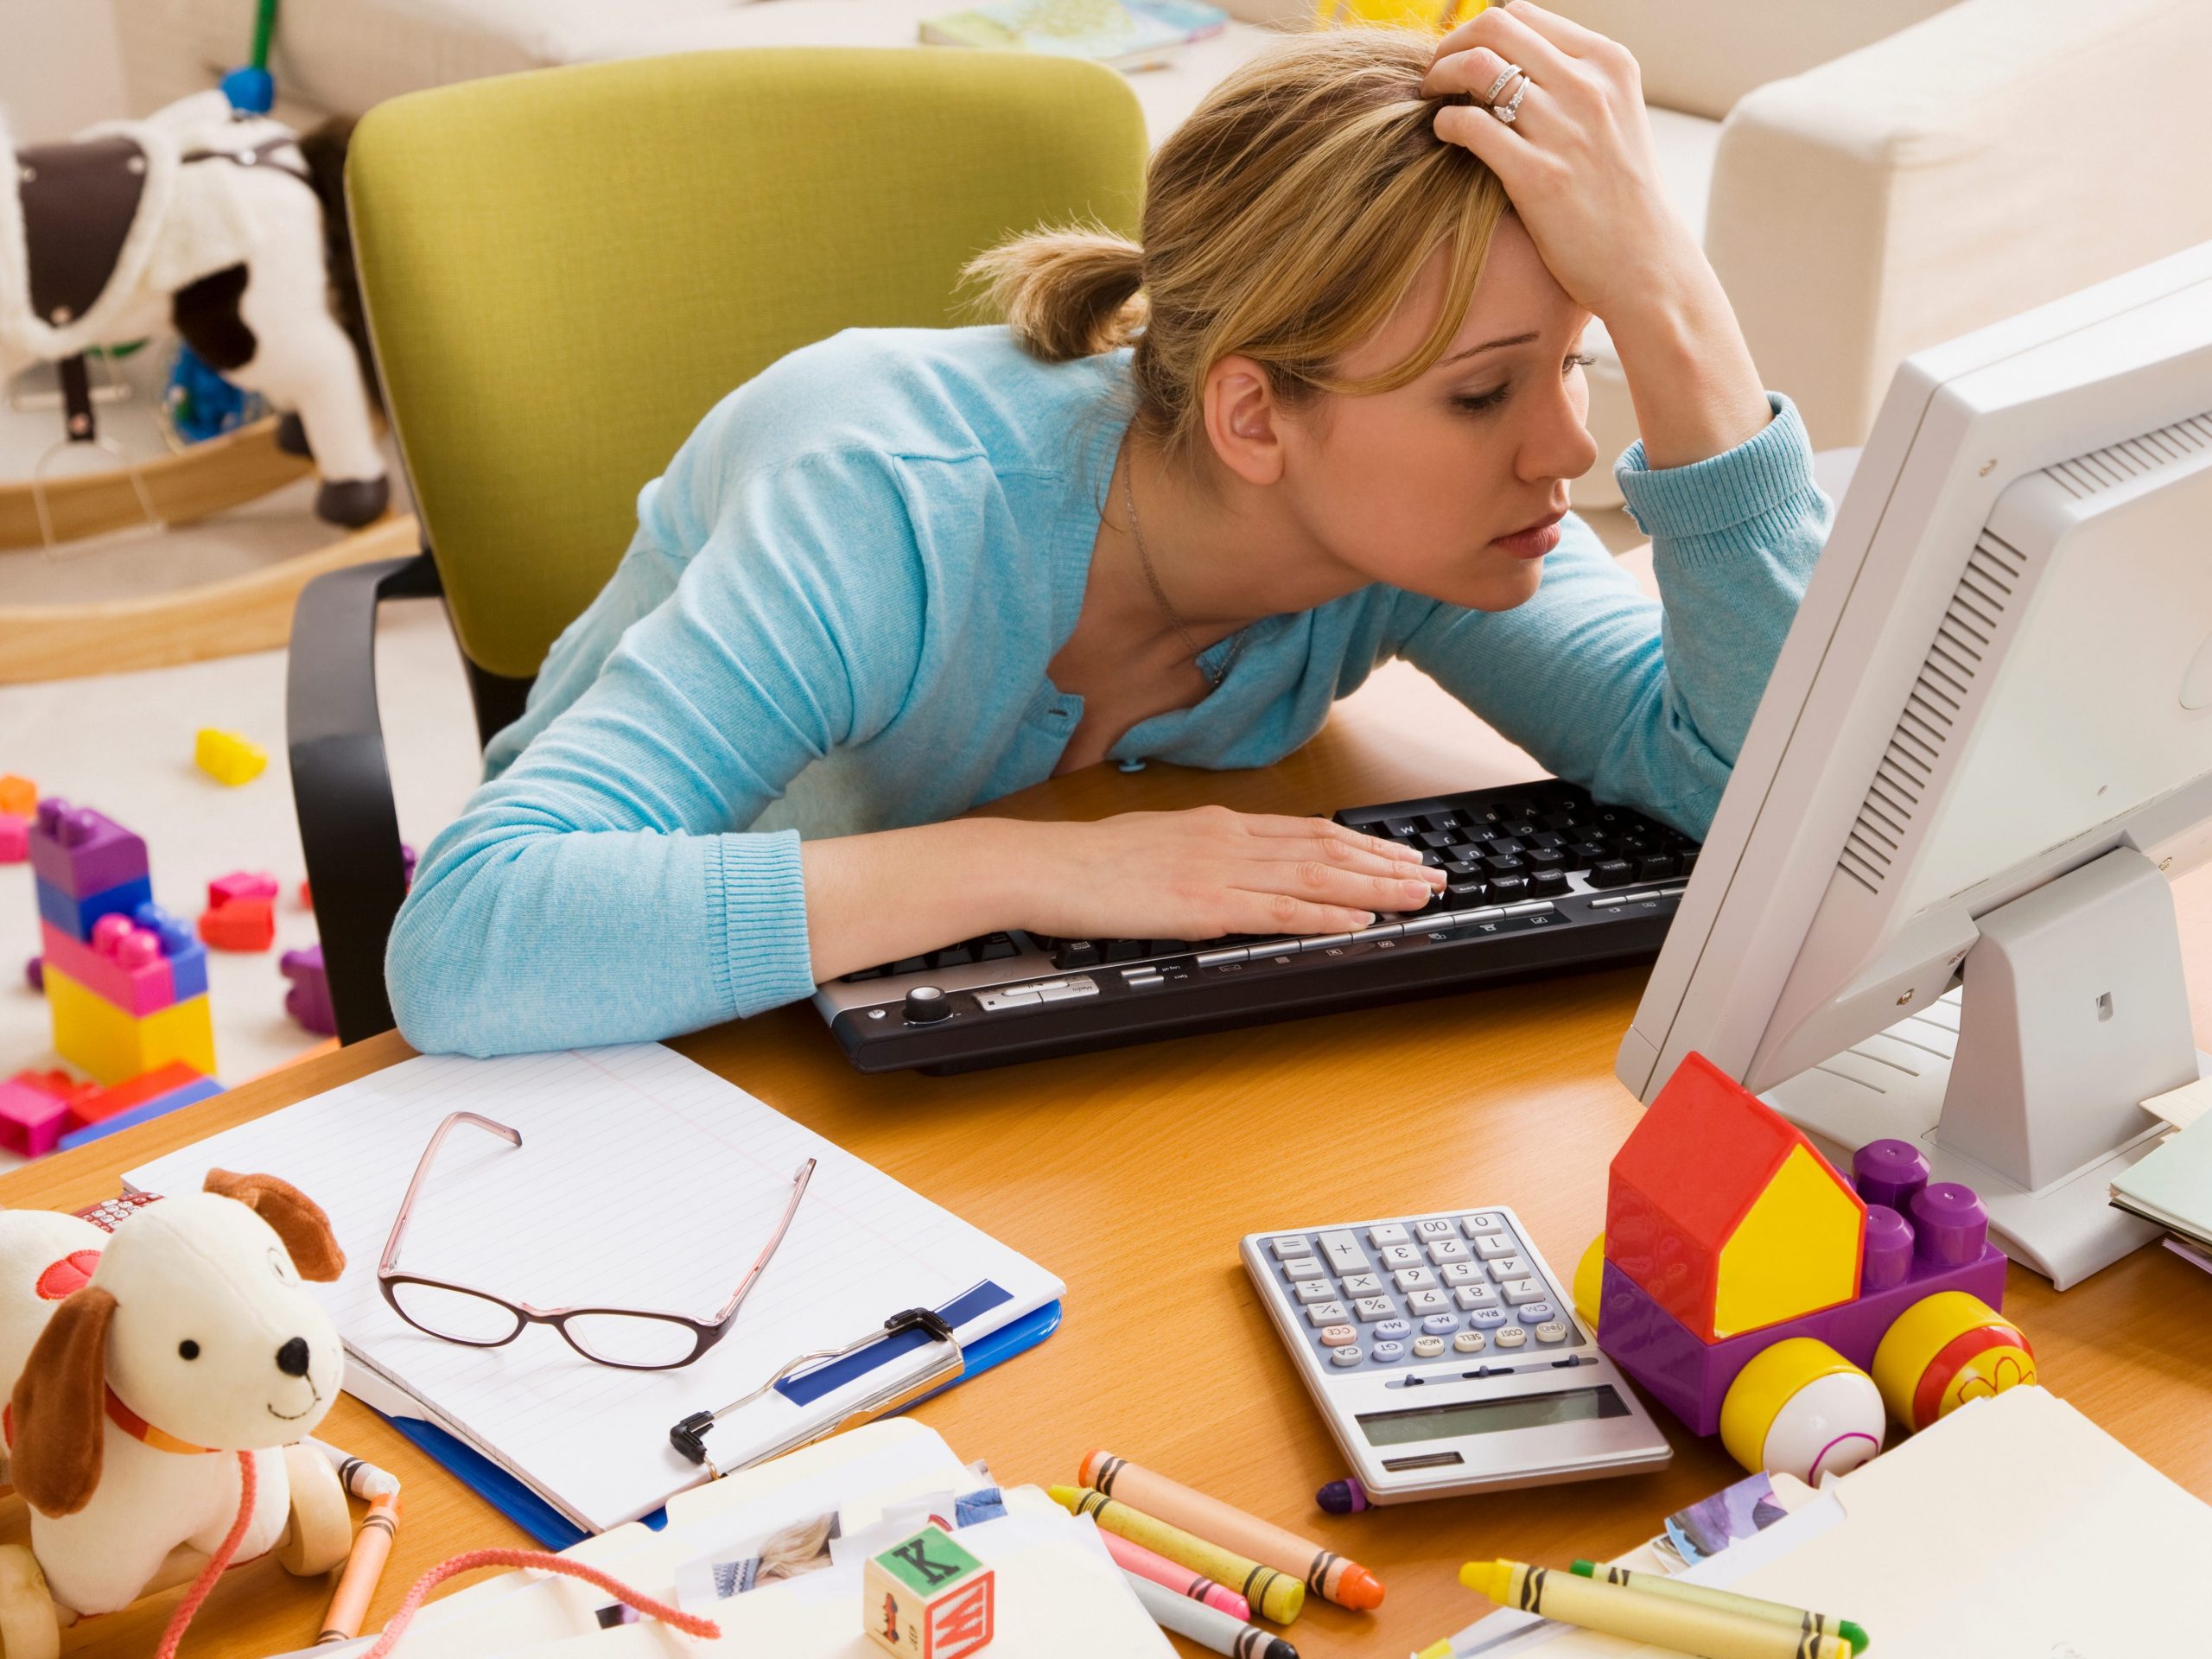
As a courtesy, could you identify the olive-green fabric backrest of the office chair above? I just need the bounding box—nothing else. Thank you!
[347,47,1146,679]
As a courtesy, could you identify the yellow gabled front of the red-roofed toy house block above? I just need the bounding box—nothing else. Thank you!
[1712,1146,1860,1338]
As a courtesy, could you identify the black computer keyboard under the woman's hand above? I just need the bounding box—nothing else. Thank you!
[814,779,1697,1071]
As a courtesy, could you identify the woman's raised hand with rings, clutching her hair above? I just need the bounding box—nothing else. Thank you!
[1421,0,1706,321]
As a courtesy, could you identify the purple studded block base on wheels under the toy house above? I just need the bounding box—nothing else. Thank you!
[1597,1141,2006,1433]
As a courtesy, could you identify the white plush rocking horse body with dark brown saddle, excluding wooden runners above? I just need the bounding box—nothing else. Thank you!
[0,93,390,529]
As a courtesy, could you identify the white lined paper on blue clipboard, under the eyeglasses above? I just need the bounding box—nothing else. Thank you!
[124,1044,1062,1531]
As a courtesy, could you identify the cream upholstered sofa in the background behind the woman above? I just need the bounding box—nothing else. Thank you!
[115,0,2212,509]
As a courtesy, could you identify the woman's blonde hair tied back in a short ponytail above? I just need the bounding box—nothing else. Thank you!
[967,29,1509,454]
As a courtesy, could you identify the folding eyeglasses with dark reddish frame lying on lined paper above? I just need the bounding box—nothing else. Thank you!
[376,1113,814,1371]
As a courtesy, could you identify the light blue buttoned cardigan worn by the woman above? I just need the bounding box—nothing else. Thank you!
[387,327,1829,1055]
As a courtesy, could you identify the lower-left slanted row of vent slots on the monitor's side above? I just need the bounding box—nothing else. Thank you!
[1836,532,2025,893]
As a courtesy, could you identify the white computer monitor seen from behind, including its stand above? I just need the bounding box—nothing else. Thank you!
[1617,244,2212,1289]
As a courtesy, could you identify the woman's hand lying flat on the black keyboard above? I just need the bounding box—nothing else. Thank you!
[1004,807,1445,940]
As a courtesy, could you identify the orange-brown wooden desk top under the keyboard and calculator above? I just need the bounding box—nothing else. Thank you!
[17,671,2212,1659]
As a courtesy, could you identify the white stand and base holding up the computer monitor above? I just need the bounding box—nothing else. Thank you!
[1765,847,2212,1289]
